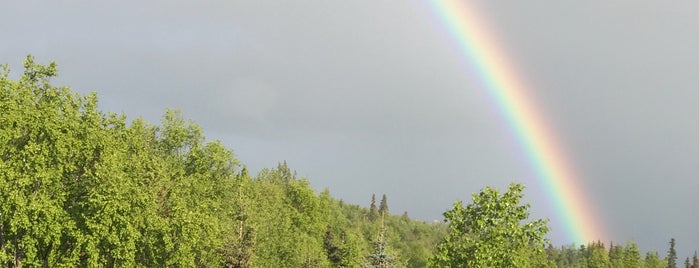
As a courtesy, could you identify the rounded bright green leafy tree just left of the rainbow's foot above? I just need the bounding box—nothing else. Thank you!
[429,183,551,267]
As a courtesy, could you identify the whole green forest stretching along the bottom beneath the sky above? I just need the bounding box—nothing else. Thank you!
[0,56,699,268]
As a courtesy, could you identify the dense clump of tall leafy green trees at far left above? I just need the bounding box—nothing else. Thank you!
[0,56,238,267]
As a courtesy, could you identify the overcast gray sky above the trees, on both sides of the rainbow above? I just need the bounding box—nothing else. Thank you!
[0,0,699,256]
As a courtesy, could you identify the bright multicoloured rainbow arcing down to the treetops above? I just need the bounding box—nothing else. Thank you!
[431,0,606,245]
